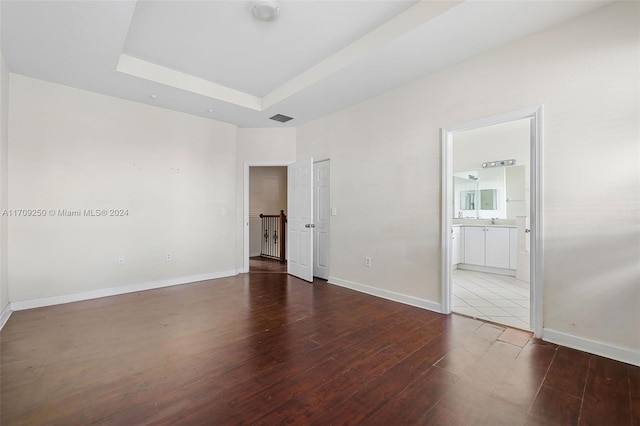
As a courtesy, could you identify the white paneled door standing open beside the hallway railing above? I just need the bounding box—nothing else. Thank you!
[287,158,313,282]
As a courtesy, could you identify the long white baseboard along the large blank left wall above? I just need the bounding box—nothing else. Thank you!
[11,269,239,311]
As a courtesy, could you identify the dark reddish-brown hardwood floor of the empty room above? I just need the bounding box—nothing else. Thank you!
[0,266,640,426]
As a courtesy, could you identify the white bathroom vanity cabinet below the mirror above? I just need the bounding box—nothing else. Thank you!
[463,226,515,269]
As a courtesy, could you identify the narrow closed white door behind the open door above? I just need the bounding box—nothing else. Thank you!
[313,160,331,280]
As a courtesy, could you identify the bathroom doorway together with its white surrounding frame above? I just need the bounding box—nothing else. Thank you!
[442,108,542,335]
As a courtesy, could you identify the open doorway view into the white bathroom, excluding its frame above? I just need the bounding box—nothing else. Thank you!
[451,118,531,330]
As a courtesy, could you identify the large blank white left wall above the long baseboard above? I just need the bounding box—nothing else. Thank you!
[9,74,237,302]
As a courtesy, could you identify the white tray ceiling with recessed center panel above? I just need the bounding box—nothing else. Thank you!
[0,0,611,127]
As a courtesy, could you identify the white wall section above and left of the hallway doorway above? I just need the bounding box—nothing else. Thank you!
[236,128,296,269]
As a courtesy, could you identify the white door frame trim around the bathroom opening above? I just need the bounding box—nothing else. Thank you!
[440,105,544,337]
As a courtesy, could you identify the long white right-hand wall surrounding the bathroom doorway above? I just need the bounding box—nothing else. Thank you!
[298,2,640,351]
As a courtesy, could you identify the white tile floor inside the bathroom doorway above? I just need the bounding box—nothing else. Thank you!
[451,269,531,330]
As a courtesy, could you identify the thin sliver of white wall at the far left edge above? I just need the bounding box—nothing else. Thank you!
[0,52,9,312]
